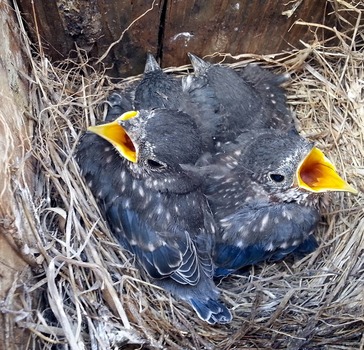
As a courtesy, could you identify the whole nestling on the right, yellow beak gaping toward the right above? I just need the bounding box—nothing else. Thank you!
[193,129,357,276]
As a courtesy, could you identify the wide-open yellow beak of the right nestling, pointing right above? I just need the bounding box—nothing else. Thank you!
[296,147,358,194]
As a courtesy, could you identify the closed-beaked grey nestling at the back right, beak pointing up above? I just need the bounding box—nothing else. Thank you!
[182,53,294,142]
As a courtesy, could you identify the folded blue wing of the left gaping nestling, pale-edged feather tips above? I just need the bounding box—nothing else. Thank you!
[106,198,200,285]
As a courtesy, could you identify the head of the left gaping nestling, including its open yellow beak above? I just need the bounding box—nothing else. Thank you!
[88,109,201,190]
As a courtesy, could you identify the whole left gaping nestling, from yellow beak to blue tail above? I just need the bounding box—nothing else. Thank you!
[77,109,231,324]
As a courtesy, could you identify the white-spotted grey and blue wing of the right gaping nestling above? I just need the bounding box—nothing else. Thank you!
[214,203,319,276]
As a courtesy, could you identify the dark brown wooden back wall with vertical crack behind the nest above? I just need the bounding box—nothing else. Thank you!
[19,0,337,77]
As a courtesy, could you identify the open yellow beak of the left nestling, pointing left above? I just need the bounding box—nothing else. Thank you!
[87,111,138,163]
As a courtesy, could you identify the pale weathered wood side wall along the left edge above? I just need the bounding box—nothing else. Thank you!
[0,1,34,350]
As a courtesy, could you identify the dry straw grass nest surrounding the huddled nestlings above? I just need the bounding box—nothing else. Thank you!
[5,5,364,349]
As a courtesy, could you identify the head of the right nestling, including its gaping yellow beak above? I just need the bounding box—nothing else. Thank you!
[228,130,357,202]
